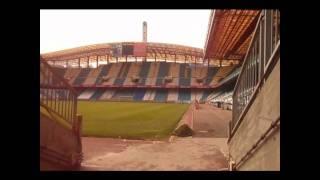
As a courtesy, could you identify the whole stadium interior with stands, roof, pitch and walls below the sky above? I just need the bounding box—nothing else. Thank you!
[40,9,280,171]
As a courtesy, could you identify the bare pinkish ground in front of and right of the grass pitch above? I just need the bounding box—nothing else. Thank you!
[81,105,231,171]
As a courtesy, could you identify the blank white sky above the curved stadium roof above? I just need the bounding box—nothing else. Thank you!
[40,10,210,53]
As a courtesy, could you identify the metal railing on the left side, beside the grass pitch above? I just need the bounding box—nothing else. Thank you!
[40,56,77,125]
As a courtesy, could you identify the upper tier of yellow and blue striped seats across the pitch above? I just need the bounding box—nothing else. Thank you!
[55,62,235,88]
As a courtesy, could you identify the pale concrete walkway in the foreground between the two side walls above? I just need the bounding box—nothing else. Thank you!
[81,137,227,171]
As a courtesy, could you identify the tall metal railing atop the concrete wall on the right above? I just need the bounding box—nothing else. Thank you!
[229,10,280,133]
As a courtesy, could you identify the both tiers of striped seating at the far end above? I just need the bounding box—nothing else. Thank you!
[48,62,239,102]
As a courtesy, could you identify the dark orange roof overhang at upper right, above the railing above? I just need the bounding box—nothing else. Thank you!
[204,9,260,60]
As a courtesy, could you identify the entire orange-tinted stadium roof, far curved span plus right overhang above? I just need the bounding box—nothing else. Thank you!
[41,9,260,64]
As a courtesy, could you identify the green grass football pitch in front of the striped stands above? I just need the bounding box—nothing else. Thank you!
[78,101,189,139]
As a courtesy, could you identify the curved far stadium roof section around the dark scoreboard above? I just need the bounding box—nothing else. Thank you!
[42,42,203,63]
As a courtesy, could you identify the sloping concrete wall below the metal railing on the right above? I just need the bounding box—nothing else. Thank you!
[228,60,280,170]
